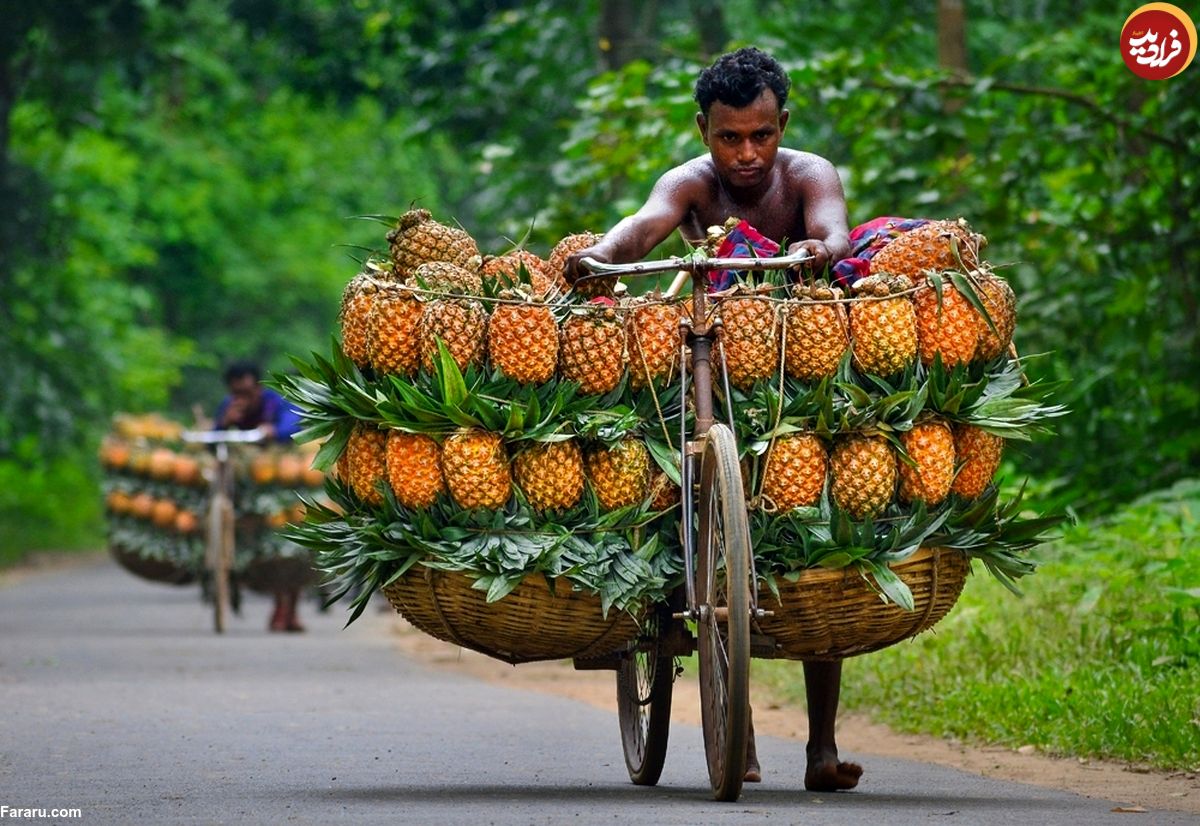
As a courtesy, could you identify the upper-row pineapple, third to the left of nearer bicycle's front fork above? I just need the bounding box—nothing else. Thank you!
[487,291,558,384]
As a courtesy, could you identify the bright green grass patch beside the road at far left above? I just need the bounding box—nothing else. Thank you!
[0,460,104,568]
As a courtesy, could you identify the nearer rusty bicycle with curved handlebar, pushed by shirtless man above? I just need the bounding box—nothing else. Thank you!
[581,253,810,801]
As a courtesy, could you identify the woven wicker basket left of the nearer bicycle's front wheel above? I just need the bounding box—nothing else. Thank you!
[383,565,637,665]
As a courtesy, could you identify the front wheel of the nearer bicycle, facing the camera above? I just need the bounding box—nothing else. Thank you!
[696,424,754,801]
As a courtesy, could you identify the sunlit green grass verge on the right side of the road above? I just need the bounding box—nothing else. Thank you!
[755,480,1200,771]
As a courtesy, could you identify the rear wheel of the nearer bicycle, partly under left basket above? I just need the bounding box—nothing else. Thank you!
[617,606,674,786]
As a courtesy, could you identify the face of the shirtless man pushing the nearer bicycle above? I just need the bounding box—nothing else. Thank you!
[696,89,787,190]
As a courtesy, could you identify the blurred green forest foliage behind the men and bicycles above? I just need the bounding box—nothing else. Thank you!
[0,0,1200,558]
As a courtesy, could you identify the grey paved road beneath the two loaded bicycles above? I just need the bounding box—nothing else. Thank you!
[0,563,1195,826]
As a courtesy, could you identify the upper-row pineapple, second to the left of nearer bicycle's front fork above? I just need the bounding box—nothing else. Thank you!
[558,300,625,395]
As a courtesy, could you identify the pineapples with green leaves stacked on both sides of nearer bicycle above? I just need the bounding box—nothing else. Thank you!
[280,210,1060,624]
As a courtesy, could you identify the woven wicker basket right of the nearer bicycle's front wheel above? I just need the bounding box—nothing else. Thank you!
[756,547,971,660]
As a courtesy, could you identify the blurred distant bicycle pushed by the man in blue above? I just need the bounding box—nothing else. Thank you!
[182,429,265,634]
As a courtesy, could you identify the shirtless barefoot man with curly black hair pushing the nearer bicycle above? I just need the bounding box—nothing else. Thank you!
[565,48,863,791]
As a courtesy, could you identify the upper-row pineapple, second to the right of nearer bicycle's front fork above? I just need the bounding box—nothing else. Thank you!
[784,286,850,382]
